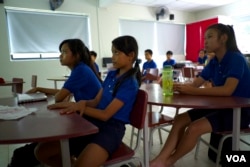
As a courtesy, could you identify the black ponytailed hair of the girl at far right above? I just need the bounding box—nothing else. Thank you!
[207,23,240,52]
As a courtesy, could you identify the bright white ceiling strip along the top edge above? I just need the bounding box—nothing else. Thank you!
[99,0,238,12]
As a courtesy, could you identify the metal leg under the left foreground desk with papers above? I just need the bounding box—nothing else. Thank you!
[60,139,71,167]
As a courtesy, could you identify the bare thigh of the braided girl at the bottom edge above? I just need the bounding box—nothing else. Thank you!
[75,143,109,167]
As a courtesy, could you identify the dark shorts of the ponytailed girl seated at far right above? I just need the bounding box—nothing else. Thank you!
[187,108,250,132]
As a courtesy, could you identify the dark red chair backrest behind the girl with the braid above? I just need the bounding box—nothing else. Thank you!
[130,89,148,129]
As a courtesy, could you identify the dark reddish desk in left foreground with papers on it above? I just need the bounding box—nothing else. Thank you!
[0,97,98,167]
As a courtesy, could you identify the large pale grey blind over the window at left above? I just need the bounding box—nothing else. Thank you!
[6,9,90,59]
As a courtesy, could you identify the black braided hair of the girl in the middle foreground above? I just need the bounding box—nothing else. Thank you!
[112,36,141,96]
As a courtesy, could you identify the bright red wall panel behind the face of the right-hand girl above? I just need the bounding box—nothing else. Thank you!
[186,18,218,62]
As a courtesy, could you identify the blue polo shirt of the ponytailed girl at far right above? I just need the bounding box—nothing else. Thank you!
[201,51,250,98]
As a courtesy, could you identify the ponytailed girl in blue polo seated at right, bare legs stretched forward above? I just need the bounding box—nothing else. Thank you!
[150,24,250,167]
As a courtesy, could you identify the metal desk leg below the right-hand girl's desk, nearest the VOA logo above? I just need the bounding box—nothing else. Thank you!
[232,108,241,151]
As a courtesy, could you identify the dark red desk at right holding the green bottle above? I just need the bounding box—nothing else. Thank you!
[141,84,250,166]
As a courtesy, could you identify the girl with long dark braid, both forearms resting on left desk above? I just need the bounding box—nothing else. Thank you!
[35,36,141,167]
